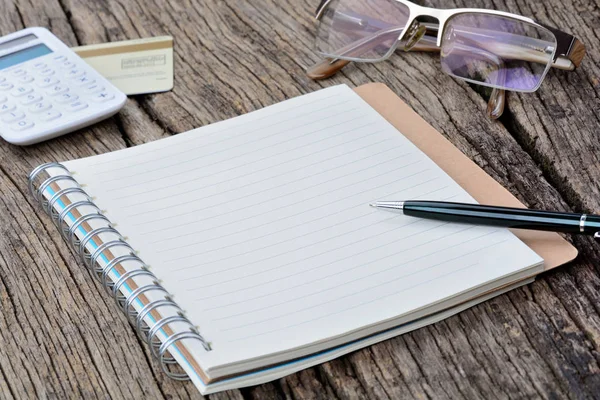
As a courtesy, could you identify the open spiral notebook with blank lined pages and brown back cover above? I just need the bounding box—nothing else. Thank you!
[30,85,576,394]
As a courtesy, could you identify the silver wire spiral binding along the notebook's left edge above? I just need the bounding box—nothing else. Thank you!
[28,163,211,380]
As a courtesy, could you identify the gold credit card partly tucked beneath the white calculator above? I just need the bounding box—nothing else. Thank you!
[72,36,173,95]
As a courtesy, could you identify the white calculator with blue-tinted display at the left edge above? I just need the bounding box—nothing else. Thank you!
[0,28,127,145]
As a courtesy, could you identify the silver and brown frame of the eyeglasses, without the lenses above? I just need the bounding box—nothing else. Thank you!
[307,0,586,119]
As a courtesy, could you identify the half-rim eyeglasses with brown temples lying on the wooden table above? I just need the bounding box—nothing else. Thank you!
[307,0,585,118]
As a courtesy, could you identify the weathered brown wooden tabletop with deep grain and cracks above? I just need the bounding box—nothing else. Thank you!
[0,0,600,399]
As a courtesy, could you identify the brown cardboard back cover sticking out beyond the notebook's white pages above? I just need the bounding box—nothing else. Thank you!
[354,83,577,270]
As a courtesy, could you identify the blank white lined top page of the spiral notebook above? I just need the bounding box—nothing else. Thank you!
[65,86,541,366]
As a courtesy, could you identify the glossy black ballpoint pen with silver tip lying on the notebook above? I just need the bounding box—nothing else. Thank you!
[371,200,600,240]
